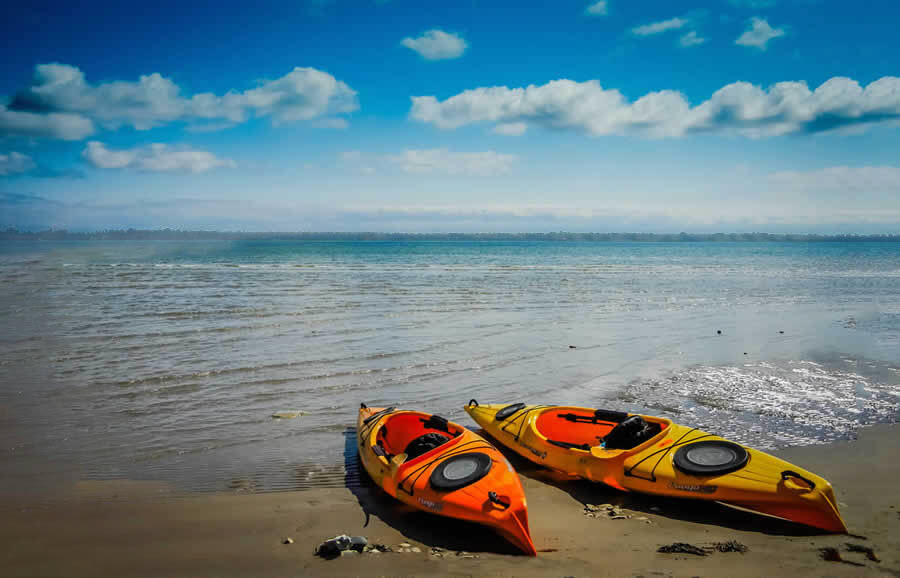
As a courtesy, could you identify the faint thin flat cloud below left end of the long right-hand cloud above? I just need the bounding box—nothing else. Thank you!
[387,149,516,176]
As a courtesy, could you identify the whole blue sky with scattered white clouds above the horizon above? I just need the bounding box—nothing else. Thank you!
[0,0,900,233]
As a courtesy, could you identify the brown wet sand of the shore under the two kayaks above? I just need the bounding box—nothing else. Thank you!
[0,426,900,577]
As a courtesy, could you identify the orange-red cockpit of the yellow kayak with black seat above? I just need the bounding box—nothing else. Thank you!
[534,407,671,452]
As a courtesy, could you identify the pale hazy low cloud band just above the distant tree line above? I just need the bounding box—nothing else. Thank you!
[8,191,900,233]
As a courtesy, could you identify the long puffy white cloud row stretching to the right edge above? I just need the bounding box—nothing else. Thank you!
[410,76,900,138]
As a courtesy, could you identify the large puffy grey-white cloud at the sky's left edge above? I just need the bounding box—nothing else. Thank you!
[7,63,359,140]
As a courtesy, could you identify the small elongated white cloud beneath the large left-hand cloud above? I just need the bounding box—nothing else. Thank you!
[81,141,237,173]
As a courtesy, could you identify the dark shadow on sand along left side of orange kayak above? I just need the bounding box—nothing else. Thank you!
[343,427,521,555]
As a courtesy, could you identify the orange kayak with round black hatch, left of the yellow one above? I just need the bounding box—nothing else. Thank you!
[356,404,537,556]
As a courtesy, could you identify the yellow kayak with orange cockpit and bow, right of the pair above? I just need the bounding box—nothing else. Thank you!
[465,399,847,533]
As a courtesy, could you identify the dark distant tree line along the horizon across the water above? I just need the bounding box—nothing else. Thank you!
[0,228,900,243]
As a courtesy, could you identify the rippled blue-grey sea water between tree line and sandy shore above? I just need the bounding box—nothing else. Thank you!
[0,241,900,491]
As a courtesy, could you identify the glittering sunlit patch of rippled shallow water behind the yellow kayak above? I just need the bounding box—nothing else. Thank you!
[617,361,900,449]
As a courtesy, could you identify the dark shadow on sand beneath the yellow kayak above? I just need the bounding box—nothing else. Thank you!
[475,429,825,536]
